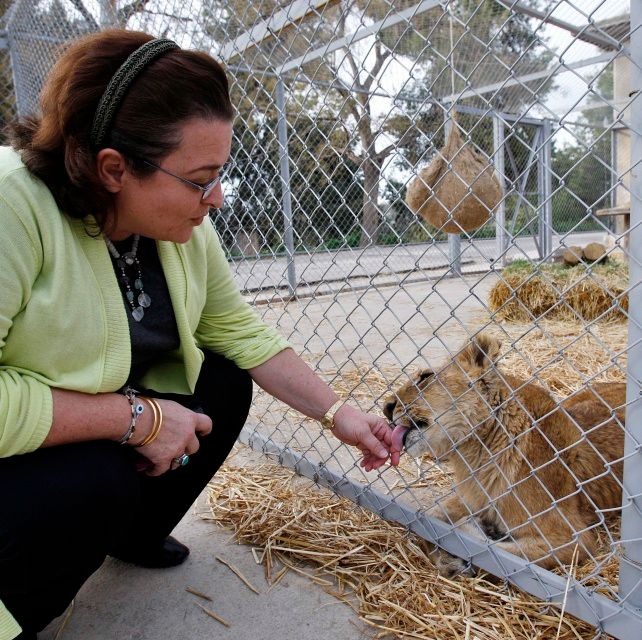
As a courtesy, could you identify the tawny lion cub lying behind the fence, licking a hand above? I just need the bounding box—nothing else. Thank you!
[384,334,625,575]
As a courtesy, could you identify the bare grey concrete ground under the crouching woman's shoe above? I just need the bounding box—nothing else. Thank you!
[38,480,372,640]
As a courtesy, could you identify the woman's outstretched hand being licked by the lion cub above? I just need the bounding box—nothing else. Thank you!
[332,404,400,471]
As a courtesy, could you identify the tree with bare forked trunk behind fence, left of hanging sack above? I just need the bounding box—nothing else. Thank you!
[302,0,550,246]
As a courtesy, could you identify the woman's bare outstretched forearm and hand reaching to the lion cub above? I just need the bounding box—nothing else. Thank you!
[249,349,399,471]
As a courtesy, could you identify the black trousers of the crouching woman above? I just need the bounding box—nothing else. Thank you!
[0,353,252,633]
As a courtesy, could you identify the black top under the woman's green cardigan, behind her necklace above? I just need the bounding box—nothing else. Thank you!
[112,236,180,384]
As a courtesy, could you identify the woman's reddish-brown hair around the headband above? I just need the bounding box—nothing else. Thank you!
[10,29,234,229]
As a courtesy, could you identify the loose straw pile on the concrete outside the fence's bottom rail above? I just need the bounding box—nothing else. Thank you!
[209,465,608,640]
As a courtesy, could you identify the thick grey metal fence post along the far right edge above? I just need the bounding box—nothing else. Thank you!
[619,2,642,609]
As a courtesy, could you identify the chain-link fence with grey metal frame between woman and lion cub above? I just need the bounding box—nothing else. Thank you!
[1,0,642,638]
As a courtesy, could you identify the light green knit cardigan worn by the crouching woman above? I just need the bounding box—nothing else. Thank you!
[0,147,288,640]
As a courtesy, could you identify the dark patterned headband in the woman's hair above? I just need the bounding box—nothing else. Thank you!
[90,38,180,150]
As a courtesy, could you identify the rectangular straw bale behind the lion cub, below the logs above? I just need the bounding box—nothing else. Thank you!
[489,258,629,322]
